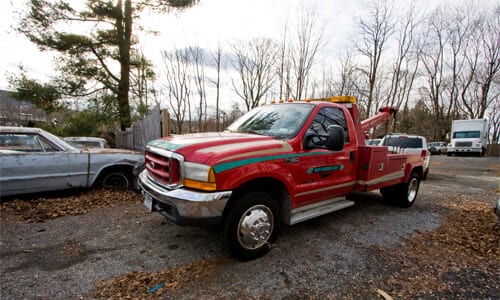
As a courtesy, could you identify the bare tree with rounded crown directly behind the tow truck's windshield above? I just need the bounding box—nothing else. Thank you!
[233,38,277,110]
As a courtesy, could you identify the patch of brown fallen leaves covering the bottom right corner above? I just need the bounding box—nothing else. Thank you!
[377,200,500,299]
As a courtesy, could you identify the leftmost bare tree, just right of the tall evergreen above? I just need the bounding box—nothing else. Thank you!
[162,48,191,133]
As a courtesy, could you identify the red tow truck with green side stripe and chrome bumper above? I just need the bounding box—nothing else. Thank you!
[139,96,423,260]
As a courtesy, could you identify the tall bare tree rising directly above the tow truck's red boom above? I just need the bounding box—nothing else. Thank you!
[356,0,395,114]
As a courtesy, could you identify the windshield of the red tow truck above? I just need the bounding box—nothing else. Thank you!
[227,103,314,139]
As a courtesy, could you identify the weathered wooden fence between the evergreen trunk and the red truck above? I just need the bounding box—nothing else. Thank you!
[115,106,170,152]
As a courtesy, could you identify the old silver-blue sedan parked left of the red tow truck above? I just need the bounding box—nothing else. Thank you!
[0,126,144,197]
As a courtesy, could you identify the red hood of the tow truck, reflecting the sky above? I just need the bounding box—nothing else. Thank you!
[148,132,292,165]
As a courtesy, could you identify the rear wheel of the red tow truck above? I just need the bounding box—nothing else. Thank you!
[380,172,420,207]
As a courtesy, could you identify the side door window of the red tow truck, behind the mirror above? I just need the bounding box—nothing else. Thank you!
[309,107,350,143]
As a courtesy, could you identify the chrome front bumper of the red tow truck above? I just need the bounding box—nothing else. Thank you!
[139,170,232,225]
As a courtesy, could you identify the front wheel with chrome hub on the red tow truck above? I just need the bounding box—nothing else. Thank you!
[223,192,280,261]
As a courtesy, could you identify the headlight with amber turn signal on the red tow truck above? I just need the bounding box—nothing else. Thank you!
[183,162,217,191]
